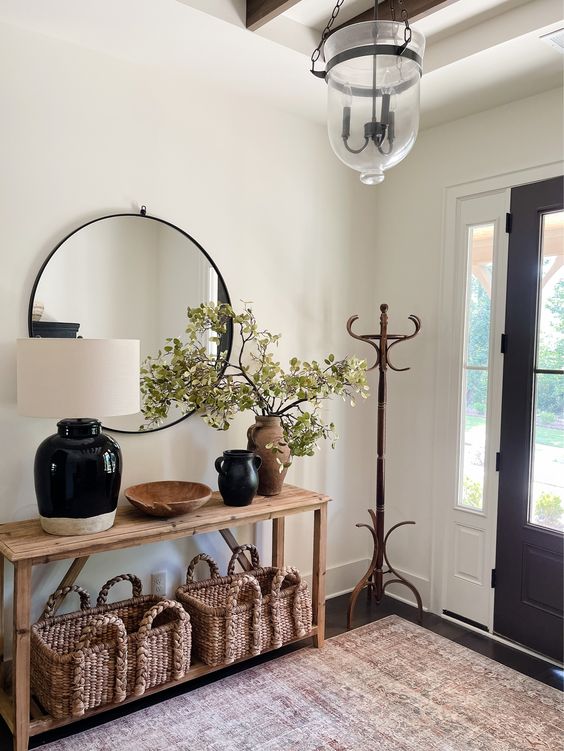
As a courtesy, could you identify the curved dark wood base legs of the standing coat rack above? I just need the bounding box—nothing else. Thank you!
[347,507,423,630]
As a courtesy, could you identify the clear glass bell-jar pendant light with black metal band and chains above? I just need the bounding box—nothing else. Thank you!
[311,0,425,185]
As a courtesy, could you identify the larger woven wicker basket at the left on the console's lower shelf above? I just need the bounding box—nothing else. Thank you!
[31,574,191,720]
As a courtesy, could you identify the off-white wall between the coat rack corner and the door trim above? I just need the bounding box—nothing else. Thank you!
[368,85,564,607]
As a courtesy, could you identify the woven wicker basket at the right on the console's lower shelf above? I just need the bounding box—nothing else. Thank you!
[176,545,312,665]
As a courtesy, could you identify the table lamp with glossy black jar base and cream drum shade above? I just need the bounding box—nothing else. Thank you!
[17,338,140,535]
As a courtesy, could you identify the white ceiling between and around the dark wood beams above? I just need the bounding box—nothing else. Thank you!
[0,0,564,127]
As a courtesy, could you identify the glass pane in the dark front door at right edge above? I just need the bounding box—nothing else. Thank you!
[529,211,564,531]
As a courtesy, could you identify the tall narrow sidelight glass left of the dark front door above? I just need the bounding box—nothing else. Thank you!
[459,223,494,510]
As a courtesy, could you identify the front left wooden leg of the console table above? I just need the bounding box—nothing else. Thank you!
[12,560,31,751]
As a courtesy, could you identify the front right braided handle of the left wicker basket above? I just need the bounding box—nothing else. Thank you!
[134,600,190,696]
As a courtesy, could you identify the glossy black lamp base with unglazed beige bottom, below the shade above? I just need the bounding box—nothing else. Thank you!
[35,418,121,535]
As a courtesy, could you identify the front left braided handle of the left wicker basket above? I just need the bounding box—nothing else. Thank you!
[72,613,127,717]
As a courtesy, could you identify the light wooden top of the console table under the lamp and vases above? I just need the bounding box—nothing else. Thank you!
[0,485,330,564]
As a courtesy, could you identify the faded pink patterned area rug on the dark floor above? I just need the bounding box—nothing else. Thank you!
[38,616,564,751]
